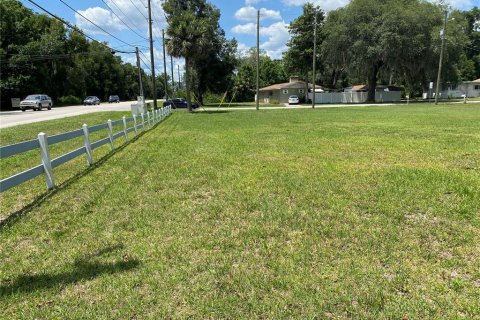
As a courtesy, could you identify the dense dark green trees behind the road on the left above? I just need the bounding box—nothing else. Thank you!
[0,0,171,109]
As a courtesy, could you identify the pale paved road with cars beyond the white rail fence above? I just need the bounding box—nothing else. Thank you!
[0,101,136,129]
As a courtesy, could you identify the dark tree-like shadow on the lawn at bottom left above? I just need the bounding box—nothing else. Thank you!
[0,245,140,298]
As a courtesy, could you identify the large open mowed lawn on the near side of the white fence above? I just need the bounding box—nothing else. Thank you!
[0,104,480,319]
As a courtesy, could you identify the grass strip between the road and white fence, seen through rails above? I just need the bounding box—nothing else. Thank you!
[0,112,141,215]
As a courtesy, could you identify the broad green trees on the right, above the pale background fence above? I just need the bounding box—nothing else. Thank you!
[283,0,480,101]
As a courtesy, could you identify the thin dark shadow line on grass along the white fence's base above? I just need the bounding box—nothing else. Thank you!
[0,123,151,232]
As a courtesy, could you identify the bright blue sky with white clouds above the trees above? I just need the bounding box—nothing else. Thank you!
[21,0,480,77]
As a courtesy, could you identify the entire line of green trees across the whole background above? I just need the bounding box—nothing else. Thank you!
[0,0,480,108]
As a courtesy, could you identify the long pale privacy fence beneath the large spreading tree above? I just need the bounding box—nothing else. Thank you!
[308,91,402,103]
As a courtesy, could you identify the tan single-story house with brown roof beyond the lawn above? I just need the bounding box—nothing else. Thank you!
[259,77,318,103]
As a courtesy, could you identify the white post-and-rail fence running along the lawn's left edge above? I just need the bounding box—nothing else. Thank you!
[0,106,172,193]
